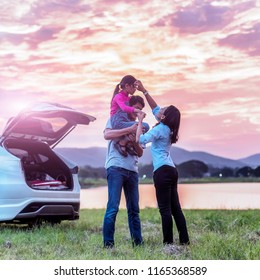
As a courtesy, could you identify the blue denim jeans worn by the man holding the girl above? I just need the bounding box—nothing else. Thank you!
[103,166,142,247]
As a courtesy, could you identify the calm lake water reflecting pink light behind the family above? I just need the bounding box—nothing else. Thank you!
[80,183,260,209]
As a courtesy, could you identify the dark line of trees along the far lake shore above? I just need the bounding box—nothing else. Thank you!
[79,160,260,179]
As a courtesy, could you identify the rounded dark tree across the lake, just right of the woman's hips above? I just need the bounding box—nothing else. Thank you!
[177,160,208,178]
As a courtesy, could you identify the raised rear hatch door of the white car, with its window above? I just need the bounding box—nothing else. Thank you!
[0,103,96,148]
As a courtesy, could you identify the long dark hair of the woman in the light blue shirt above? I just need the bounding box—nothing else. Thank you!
[161,105,181,143]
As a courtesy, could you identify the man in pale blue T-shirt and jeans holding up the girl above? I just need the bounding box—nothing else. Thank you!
[103,96,144,248]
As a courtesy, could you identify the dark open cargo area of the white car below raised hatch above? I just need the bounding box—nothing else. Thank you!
[4,139,74,191]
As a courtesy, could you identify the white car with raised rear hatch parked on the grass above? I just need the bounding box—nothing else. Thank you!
[0,103,95,225]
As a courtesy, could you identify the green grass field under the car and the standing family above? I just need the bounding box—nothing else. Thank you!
[0,208,260,260]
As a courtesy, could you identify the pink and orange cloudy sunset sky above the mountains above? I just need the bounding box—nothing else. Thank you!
[0,0,260,159]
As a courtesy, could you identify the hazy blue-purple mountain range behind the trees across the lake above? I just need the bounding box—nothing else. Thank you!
[55,146,260,168]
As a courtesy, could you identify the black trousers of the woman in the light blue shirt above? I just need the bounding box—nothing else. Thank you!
[153,165,189,244]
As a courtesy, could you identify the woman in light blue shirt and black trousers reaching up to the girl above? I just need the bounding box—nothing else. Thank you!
[136,82,190,245]
